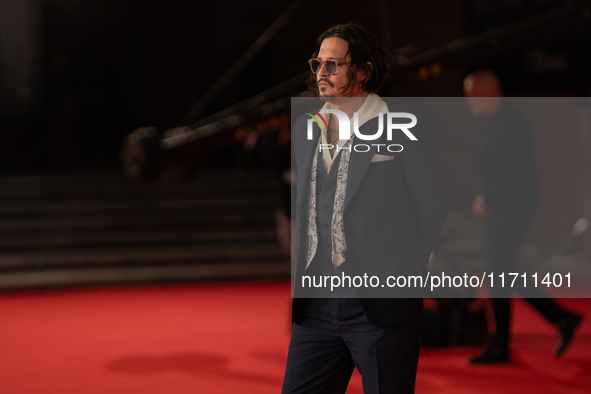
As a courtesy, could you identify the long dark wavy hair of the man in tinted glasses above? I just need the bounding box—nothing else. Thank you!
[307,23,388,96]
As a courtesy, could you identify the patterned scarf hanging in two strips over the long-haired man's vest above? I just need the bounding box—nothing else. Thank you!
[306,139,351,269]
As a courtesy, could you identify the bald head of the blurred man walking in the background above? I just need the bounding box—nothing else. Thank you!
[464,70,503,116]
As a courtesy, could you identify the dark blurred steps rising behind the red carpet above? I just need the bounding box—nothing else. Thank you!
[0,170,290,290]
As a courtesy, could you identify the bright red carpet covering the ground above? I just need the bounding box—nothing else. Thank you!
[0,282,591,394]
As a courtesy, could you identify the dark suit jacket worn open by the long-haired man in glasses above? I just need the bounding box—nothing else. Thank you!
[292,103,447,327]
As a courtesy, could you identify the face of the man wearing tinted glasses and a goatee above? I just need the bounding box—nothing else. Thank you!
[316,37,355,97]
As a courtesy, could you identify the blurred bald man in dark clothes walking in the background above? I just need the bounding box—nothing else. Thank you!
[464,70,581,364]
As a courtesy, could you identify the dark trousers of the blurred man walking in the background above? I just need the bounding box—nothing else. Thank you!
[486,209,567,347]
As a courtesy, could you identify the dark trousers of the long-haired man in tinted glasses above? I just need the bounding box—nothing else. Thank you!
[282,298,421,394]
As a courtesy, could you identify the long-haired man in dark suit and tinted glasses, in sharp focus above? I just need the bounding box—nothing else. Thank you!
[282,24,447,394]
